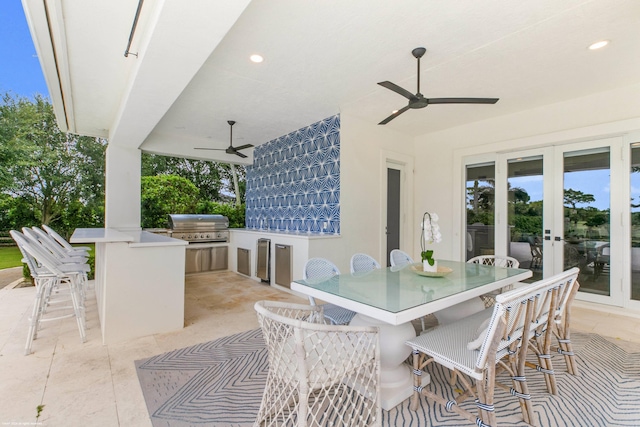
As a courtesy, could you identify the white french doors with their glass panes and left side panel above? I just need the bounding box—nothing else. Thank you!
[466,138,629,305]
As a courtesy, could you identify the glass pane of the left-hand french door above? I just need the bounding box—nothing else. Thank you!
[507,156,544,281]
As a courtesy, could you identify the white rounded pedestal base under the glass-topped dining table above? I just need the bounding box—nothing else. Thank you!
[350,314,430,411]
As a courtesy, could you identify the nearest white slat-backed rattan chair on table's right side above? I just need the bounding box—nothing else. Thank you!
[407,269,578,426]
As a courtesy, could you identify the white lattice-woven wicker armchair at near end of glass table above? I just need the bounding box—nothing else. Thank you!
[254,301,382,427]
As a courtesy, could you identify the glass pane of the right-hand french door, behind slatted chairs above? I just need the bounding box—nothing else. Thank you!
[556,148,611,296]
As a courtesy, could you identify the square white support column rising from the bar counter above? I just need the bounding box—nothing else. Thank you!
[105,144,141,230]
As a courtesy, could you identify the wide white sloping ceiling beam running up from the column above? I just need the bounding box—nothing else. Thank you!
[109,0,250,148]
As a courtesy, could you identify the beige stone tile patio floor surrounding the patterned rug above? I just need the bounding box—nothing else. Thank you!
[0,272,640,427]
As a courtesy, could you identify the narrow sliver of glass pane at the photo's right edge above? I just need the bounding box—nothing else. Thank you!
[631,143,640,301]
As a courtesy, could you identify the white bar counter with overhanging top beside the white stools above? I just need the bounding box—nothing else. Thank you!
[70,228,188,344]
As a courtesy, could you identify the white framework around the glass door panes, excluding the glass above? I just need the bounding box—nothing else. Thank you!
[460,139,628,310]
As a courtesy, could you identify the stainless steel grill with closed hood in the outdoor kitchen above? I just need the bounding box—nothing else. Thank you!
[169,214,229,243]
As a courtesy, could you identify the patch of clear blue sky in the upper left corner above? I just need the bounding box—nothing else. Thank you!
[0,0,49,98]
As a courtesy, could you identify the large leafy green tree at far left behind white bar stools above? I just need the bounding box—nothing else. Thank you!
[0,93,105,234]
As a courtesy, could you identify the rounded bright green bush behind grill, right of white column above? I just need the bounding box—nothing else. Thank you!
[140,175,199,228]
